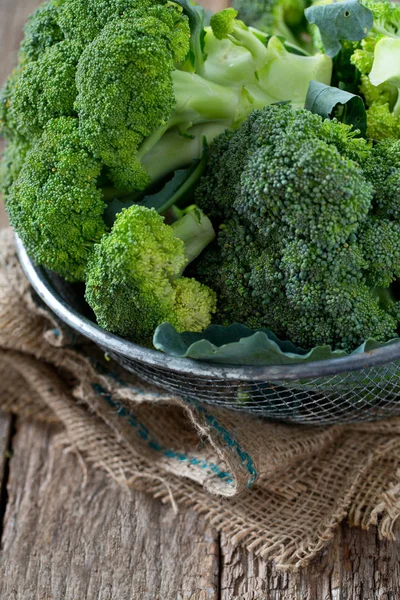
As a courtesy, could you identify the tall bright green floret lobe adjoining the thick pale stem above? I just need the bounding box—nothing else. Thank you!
[76,6,189,189]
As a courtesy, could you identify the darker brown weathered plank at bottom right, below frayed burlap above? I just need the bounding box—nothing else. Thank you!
[220,524,400,600]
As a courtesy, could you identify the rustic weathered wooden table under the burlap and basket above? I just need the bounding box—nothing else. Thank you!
[0,0,400,600]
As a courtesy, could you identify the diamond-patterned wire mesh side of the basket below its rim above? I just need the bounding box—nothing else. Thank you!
[105,352,400,425]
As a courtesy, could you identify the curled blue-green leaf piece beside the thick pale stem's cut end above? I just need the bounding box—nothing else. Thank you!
[304,81,367,137]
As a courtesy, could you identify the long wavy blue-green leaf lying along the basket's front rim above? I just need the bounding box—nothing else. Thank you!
[153,323,400,366]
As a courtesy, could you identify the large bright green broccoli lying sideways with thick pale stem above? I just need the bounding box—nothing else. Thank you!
[0,0,332,280]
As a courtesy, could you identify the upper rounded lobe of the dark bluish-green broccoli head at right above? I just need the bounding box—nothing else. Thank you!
[197,106,372,246]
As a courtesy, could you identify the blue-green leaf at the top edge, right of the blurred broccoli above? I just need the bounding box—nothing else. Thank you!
[304,0,374,58]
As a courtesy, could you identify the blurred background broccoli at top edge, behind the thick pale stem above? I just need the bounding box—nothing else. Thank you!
[233,0,308,45]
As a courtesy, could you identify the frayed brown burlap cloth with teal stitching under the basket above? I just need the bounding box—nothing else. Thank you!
[0,230,400,569]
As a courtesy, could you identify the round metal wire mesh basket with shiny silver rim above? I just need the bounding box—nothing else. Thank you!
[17,239,400,425]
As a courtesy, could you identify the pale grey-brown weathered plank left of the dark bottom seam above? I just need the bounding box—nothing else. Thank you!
[0,423,219,600]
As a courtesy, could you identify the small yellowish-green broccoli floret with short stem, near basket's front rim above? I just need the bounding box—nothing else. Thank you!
[86,205,216,346]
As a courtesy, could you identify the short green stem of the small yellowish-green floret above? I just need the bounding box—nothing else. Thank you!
[171,207,215,278]
